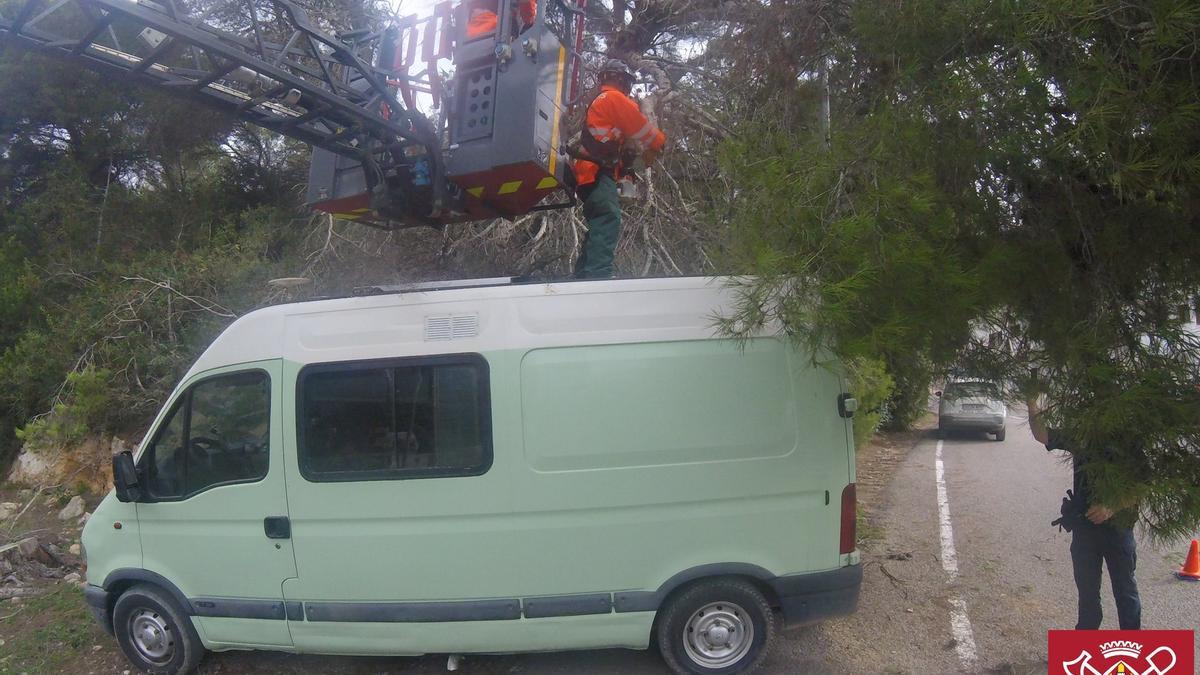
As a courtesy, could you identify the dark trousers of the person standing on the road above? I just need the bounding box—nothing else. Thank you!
[1070,522,1141,631]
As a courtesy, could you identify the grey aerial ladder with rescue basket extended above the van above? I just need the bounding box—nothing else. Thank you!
[0,0,587,229]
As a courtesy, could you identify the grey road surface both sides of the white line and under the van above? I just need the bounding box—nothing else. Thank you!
[192,413,1200,675]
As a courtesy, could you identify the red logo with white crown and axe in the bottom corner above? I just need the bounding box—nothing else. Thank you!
[1049,631,1195,675]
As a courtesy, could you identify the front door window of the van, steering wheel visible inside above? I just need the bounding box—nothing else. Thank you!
[146,371,271,500]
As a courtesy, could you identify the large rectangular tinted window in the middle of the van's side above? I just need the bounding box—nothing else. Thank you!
[298,356,492,482]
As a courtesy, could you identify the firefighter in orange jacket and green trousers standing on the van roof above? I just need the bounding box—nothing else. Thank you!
[575,59,667,279]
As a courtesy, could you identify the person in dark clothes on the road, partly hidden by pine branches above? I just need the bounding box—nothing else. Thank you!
[1026,392,1141,631]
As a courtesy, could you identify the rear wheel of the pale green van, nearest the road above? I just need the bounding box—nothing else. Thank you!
[656,579,776,675]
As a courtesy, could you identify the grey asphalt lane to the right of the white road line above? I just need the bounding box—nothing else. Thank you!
[936,410,1200,663]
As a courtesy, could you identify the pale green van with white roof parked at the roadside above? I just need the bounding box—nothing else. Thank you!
[83,279,862,673]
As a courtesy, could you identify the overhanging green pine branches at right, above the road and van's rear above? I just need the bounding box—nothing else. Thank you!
[722,0,1200,537]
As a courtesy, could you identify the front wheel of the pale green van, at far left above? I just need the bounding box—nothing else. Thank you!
[113,584,204,675]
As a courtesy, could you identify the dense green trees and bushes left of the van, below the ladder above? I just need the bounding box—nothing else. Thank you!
[0,50,307,468]
